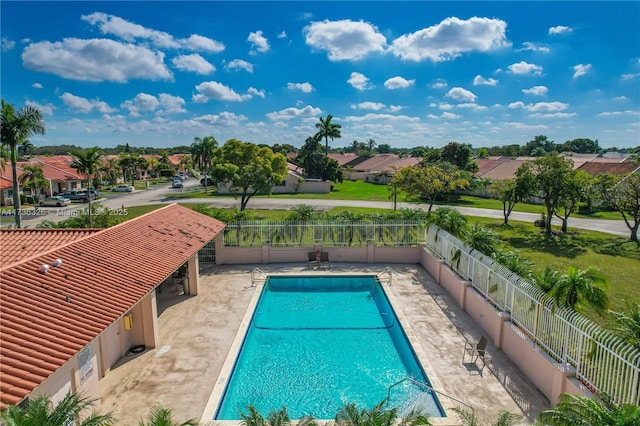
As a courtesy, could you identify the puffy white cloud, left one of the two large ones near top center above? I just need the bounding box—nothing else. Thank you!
[303,19,387,61]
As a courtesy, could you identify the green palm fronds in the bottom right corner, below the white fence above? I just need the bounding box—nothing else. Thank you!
[538,394,640,426]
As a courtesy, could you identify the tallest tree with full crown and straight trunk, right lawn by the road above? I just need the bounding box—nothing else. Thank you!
[516,154,573,235]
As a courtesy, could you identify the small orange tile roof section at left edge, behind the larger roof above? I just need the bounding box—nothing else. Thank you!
[0,228,99,268]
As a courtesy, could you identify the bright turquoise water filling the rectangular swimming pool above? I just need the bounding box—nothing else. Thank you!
[215,276,442,420]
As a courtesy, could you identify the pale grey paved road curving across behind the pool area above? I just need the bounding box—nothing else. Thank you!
[3,179,630,237]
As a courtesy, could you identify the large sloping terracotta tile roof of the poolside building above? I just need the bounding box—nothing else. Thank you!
[0,204,225,405]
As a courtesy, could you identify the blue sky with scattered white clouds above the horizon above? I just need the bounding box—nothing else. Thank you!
[0,1,640,148]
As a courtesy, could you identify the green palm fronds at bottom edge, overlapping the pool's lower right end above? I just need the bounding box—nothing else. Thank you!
[334,400,431,426]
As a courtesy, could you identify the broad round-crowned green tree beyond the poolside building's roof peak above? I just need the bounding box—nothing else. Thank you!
[211,139,288,210]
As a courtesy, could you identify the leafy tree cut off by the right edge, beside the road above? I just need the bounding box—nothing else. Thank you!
[596,173,640,243]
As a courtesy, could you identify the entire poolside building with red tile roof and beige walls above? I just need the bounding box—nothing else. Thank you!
[0,204,225,408]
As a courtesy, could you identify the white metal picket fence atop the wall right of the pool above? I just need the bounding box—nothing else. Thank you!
[426,225,640,405]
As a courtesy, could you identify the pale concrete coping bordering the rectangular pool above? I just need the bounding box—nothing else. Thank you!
[200,271,459,426]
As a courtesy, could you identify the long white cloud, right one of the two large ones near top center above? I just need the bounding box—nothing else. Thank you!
[389,17,511,62]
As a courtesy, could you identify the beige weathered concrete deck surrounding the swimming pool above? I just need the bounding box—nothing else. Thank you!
[100,262,549,425]
